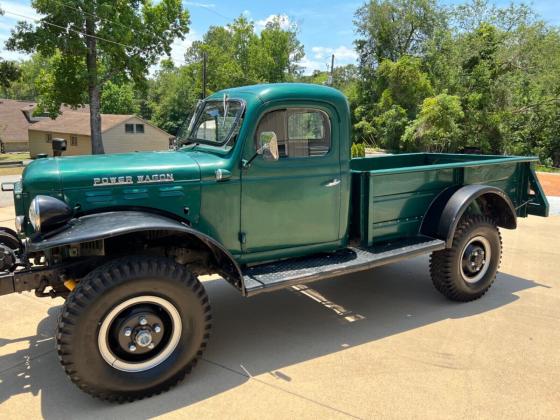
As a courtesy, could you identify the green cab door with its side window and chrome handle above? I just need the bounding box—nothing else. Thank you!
[240,106,341,256]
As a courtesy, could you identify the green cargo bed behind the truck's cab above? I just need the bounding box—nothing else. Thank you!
[350,153,548,247]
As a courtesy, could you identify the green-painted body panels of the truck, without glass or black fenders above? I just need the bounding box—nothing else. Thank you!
[10,84,546,263]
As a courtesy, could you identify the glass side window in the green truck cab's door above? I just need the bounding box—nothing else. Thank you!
[255,108,331,159]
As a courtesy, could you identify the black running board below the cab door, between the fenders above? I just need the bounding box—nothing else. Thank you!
[243,236,445,296]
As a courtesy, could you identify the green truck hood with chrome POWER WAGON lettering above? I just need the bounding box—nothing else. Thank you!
[23,151,200,192]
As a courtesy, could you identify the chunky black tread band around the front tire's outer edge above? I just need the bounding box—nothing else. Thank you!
[56,256,212,403]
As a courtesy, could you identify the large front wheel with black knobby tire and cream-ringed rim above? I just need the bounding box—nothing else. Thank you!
[57,257,211,402]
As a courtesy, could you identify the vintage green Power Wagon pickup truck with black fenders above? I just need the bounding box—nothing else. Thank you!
[0,84,548,402]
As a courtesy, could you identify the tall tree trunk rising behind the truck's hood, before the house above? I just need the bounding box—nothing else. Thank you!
[86,17,105,155]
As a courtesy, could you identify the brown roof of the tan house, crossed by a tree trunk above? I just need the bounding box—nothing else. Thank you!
[29,110,140,136]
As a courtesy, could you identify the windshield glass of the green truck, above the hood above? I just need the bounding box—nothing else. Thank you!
[184,98,243,147]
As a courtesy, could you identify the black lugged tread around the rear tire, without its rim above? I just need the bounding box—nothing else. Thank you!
[430,215,502,302]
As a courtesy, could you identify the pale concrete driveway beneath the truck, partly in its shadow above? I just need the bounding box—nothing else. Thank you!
[0,209,560,419]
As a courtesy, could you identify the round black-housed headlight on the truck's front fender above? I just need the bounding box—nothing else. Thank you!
[29,195,72,233]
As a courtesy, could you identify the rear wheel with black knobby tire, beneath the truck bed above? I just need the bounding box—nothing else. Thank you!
[430,215,502,302]
